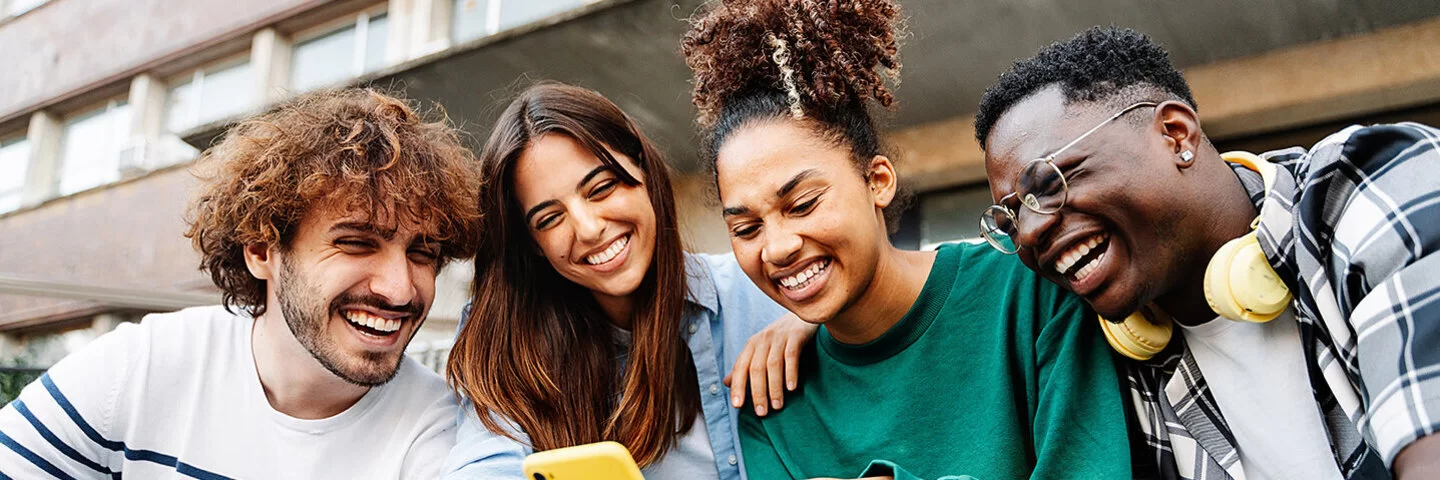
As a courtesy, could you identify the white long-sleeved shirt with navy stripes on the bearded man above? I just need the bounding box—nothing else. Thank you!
[0,307,456,479]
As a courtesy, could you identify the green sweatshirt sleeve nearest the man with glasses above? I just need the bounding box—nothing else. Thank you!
[1031,289,1130,479]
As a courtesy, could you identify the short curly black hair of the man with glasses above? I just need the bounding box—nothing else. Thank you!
[975,27,1198,148]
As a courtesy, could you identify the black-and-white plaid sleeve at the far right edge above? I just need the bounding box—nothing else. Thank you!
[1313,124,1440,466]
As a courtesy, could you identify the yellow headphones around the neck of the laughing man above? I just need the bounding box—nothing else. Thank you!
[1100,151,1290,360]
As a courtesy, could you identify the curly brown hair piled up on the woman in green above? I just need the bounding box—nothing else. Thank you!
[681,0,910,231]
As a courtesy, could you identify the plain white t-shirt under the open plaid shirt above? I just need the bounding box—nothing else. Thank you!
[1184,310,1341,480]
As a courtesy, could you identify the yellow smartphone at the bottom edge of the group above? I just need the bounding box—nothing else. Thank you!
[524,441,645,480]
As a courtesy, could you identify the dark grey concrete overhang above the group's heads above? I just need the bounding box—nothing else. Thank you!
[184,0,1440,172]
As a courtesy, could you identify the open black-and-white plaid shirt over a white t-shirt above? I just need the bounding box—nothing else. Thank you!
[1123,123,1440,479]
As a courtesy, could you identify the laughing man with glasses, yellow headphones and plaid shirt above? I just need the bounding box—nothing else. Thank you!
[975,29,1440,479]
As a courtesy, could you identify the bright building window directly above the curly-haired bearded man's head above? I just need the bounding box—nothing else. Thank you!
[289,12,390,92]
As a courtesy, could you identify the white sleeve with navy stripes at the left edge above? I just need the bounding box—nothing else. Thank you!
[0,317,139,479]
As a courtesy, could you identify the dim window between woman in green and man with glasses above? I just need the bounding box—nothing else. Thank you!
[916,183,995,249]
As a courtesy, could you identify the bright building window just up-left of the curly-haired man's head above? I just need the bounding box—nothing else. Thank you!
[166,58,255,133]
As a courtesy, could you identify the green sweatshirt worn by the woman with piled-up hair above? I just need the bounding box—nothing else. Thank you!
[740,244,1130,480]
